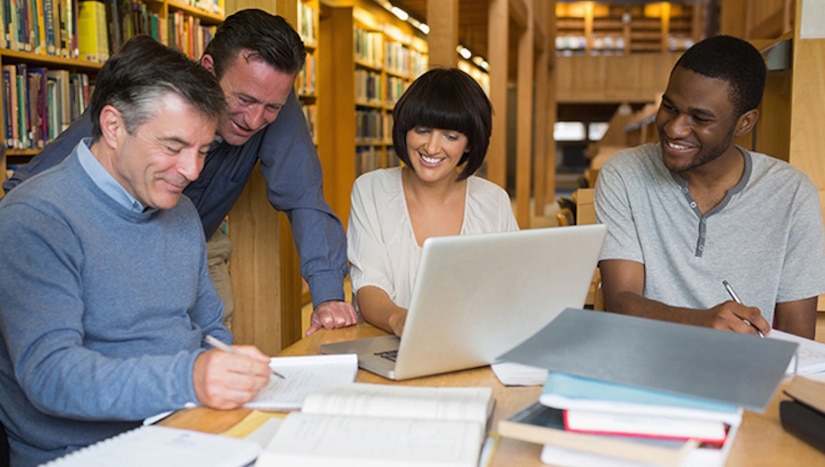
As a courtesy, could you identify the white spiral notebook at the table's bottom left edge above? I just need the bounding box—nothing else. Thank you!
[44,425,261,467]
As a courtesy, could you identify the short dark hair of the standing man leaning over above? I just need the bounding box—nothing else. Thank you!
[204,8,306,80]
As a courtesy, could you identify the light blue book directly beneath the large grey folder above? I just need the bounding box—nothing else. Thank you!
[539,371,742,425]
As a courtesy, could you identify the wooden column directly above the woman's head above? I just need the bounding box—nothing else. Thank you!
[427,0,458,68]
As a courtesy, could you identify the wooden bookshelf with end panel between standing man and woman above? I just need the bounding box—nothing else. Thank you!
[317,1,428,229]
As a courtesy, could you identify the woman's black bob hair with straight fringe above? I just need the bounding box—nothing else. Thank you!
[392,68,493,180]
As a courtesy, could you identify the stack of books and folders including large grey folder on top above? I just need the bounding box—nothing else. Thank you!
[498,309,799,466]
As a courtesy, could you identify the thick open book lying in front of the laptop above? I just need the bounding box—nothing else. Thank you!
[256,383,495,467]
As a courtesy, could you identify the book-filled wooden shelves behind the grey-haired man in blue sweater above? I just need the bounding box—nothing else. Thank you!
[0,0,223,196]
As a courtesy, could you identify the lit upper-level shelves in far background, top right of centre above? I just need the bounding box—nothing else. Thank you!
[556,2,702,55]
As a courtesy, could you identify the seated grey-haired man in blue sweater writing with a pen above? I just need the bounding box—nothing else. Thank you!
[0,36,270,466]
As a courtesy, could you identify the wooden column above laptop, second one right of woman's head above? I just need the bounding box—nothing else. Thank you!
[511,1,535,228]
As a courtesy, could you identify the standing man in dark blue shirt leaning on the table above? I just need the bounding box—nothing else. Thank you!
[3,9,358,334]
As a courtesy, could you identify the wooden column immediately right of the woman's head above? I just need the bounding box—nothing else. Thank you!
[487,0,510,187]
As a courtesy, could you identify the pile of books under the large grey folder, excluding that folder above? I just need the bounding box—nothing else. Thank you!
[498,372,742,466]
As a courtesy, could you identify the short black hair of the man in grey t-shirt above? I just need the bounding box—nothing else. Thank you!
[673,35,767,118]
